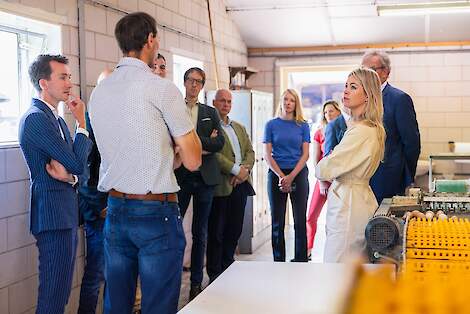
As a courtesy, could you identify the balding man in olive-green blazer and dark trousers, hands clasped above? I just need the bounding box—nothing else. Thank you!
[207,89,255,282]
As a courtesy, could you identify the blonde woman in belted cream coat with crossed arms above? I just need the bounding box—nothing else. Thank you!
[315,68,385,263]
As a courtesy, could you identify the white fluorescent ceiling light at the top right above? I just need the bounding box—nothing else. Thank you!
[377,1,470,16]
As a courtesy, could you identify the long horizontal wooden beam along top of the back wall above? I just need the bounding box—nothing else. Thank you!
[248,40,470,54]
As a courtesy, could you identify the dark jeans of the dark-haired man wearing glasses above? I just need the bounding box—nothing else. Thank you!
[178,175,214,285]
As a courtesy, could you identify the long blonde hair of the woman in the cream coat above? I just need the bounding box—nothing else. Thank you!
[349,67,386,160]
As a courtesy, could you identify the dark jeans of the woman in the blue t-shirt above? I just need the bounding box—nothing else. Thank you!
[268,167,309,262]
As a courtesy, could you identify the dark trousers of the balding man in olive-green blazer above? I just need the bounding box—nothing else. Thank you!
[207,182,248,281]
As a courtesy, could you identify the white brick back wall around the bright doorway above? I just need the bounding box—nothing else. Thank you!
[248,51,470,162]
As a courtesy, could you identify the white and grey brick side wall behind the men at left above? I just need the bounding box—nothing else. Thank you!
[0,0,248,314]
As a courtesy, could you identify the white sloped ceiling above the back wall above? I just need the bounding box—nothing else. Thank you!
[224,0,470,48]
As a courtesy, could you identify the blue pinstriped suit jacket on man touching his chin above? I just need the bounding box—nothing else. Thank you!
[19,99,91,234]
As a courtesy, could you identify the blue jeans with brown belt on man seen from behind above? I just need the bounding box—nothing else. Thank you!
[103,197,186,314]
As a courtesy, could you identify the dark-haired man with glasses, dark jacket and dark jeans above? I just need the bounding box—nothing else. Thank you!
[175,68,225,300]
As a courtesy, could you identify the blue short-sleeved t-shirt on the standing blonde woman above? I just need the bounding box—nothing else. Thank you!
[263,118,310,169]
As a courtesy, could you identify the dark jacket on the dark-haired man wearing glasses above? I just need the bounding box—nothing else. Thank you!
[175,103,225,186]
